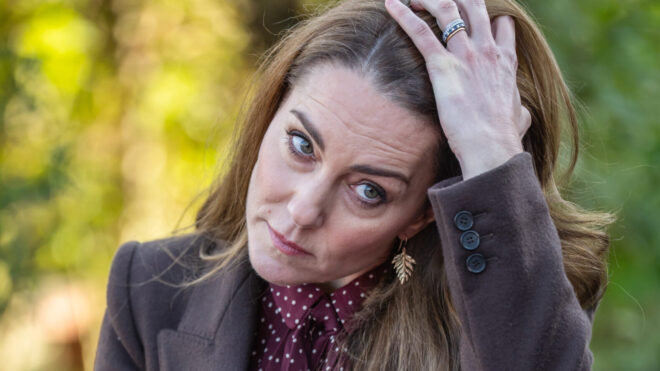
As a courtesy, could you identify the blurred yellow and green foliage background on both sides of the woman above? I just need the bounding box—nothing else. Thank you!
[0,0,660,371]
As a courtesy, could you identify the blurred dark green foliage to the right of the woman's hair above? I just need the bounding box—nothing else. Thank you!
[529,0,660,370]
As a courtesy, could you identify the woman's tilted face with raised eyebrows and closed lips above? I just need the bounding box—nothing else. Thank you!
[246,65,438,289]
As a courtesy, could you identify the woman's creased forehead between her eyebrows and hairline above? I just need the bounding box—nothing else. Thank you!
[283,64,439,176]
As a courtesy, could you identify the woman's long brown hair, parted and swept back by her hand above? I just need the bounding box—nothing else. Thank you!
[191,0,613,370]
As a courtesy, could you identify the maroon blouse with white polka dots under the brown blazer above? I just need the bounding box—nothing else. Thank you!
[250,264,387,371]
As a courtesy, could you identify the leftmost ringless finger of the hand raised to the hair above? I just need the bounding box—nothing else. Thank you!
[385,0,447,61]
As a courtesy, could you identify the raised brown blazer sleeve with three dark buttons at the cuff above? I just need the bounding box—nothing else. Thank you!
[428,152,595,371]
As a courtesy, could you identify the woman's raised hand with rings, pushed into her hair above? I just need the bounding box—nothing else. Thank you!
[385,0,531,179]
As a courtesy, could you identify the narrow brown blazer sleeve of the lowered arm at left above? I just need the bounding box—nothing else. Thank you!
[94,241,144,371]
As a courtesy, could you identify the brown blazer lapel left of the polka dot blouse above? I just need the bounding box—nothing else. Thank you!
[157,259,261,371]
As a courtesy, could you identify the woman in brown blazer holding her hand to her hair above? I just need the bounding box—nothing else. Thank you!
[96,0,611,370]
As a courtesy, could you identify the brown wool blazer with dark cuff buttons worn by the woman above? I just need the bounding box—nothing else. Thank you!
[95,152,596,371]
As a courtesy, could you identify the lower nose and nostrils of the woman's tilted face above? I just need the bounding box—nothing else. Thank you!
[287,182,326,228]
